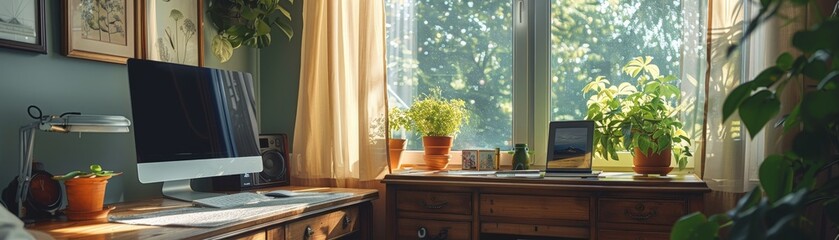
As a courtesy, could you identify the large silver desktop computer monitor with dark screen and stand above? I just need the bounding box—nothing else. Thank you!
[128,59,262,201]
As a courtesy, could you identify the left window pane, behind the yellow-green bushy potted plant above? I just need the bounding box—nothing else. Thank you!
[385,0,513,150]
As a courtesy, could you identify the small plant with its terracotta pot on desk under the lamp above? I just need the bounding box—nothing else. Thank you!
[53,164,122,220]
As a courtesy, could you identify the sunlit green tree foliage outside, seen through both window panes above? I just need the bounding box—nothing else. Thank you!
[385,0,705,149]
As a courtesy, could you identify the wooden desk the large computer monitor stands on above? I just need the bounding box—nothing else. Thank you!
[26,187,379,239]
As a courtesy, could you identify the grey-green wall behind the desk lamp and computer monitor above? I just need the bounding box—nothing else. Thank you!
[0,0,260,203]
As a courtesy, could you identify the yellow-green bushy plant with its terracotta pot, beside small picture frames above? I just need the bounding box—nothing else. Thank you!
[406,89,469,169]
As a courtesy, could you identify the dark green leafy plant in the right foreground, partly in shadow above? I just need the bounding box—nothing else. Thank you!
[671,0,839,239]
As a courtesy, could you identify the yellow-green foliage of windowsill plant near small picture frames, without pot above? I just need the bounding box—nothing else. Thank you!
[406,89,469,136]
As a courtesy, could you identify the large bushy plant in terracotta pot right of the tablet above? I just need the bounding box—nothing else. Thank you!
[583,57,691,175]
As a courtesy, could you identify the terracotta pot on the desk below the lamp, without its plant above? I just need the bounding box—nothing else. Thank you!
[64,176,111,220]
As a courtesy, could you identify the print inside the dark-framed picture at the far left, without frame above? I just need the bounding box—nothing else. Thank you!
[0,0,38,44]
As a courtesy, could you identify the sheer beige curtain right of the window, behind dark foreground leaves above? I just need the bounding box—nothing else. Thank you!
[700,0,805,213]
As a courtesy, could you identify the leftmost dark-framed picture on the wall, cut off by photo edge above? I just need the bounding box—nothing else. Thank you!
[0,0,47,54]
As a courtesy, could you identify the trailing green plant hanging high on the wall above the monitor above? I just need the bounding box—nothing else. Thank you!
[207,0,294,62]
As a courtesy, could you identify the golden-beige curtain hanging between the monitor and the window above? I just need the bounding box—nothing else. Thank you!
[291,0,387,188]
